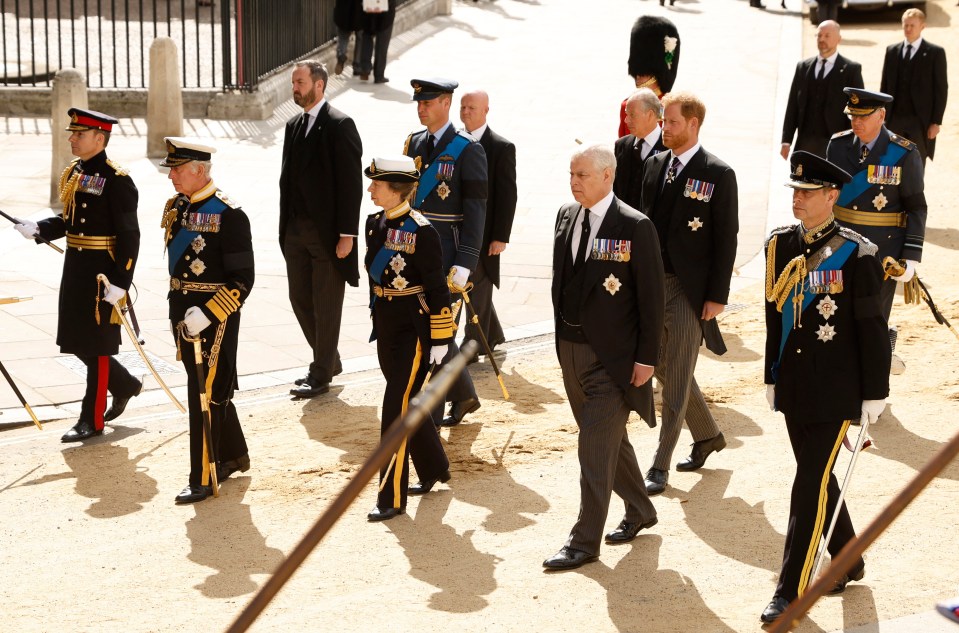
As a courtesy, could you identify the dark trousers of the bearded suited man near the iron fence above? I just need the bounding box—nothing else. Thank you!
[283,216,346,383]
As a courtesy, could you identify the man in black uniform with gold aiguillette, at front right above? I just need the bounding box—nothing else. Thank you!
[761,151,890,622]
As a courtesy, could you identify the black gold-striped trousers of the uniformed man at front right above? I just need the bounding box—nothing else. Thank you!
[776,415,863,601]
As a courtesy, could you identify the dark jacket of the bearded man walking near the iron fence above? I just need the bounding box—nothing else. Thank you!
[280,102,363,286]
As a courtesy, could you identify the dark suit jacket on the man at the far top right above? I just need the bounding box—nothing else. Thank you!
[879,39,949,158]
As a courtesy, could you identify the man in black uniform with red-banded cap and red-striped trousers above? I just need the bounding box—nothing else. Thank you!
[15,108,143,442]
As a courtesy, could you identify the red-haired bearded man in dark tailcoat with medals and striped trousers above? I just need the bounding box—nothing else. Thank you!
[640,92,739,494]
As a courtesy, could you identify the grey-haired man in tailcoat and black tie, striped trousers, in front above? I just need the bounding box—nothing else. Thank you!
[543,145,663,570]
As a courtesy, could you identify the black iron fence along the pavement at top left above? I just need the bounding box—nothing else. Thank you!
[0,0,407,91]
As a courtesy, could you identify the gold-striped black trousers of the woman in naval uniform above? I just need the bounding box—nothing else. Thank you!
[373,296,450,509]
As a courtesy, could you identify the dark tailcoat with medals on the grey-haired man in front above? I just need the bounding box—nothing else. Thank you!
[552,197,665,426]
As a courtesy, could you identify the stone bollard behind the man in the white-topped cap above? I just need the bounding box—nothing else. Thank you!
[147,37,183,158]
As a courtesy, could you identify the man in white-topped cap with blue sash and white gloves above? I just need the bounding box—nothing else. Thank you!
[160,137,254,503]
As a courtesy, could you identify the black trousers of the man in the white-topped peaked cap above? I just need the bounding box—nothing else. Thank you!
[174,312,248,486]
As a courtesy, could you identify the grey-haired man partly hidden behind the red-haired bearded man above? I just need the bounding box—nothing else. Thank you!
[613,88,666,209]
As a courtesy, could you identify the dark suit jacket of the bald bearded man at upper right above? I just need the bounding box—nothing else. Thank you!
[782,55,863,150]
